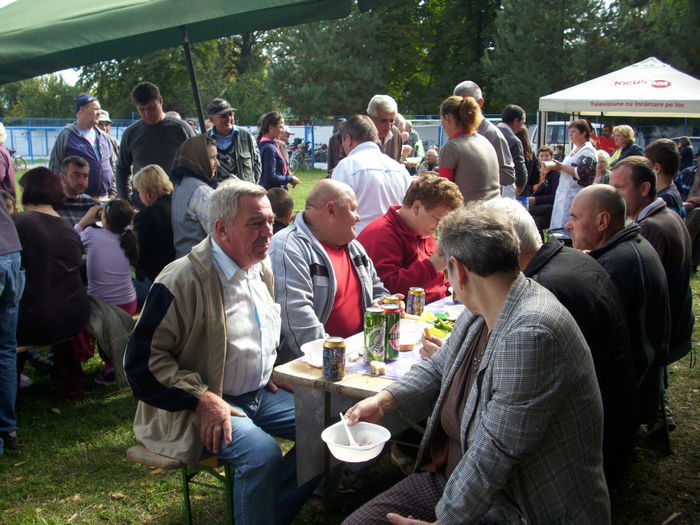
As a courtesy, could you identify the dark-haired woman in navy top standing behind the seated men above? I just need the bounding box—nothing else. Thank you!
[258,111,299,190]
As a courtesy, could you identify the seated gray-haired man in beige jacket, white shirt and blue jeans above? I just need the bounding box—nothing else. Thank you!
[124,180,314,524]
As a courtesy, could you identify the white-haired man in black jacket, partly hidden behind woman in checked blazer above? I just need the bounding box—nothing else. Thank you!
[486,199,635,483]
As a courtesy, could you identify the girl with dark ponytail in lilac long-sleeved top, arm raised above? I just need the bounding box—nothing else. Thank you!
[75,199,138,384]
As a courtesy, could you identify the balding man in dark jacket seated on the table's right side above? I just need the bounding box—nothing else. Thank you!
[566,184,671,424]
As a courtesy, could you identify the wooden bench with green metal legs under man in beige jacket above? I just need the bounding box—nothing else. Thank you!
[126,445,236,525]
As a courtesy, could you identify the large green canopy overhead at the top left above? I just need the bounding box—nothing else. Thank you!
[0,0,386,84]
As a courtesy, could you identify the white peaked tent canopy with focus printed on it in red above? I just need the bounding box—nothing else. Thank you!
[539,57,700,118]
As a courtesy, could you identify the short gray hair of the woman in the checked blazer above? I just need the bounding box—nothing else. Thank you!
[438,202,520,277]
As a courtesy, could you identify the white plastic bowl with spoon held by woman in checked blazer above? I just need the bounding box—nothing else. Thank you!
[321,421,391,463]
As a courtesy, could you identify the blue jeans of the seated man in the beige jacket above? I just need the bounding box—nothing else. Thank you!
[217,388,318,525]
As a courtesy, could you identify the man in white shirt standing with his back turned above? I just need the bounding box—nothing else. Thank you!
[332,115,412,235]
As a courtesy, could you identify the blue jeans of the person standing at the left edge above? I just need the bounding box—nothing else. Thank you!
[0,252,24,456]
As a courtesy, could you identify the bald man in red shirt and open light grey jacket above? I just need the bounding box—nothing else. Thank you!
[270,179,388,363]
